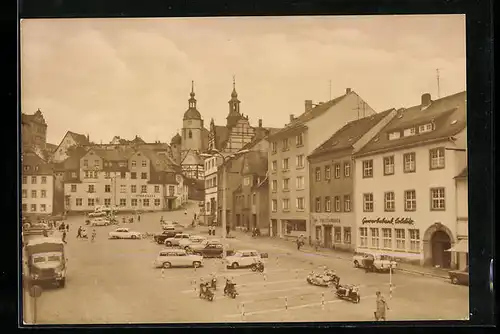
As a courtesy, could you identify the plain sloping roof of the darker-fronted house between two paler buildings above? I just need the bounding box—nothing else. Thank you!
[309,109,395,157]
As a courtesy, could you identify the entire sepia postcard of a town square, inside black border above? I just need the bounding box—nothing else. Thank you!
[19,15,469,325]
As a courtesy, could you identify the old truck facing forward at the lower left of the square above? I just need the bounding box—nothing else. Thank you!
[23,237,68,288]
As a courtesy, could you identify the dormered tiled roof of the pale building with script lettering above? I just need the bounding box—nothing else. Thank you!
[357,92,466,155]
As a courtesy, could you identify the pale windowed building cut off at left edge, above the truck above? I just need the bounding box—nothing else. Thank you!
[21,150,54,216]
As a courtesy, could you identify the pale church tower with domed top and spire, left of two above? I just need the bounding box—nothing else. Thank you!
[181,81,203,152]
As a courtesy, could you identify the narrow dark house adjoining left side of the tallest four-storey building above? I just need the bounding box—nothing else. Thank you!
[232,151,269,234]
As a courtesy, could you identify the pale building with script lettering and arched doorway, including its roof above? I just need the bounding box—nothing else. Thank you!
[354,92,467,268]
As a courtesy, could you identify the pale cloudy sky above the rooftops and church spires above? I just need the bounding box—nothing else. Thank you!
[20,15,466,144]
